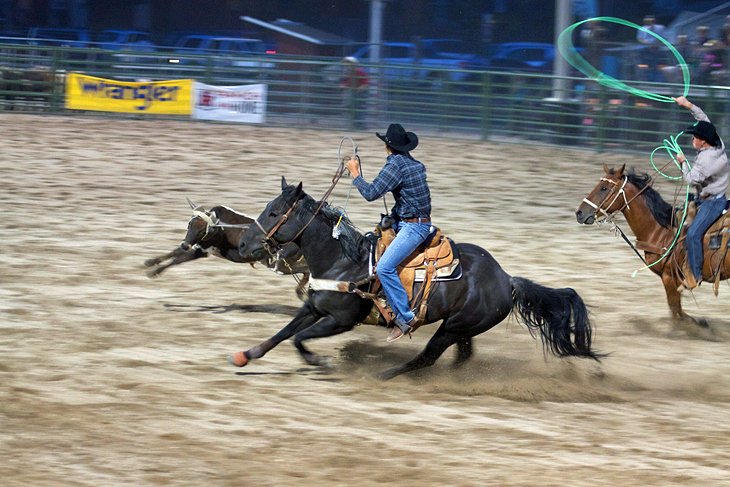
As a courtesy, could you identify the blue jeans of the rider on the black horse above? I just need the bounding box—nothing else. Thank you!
[376,222,431,330]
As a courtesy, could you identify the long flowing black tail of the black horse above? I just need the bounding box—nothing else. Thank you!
[510,277,600,360]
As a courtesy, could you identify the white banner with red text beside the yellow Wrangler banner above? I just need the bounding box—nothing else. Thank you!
[193,81,266,123]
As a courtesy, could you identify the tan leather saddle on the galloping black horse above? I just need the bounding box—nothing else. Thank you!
[371,219,461,329]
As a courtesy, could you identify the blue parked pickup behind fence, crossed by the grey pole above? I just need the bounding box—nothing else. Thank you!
[353,39,482,81]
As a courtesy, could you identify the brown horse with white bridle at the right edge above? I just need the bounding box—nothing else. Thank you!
[575,164,730,327]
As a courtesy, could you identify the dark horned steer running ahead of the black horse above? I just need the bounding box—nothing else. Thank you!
[144,200,309,298]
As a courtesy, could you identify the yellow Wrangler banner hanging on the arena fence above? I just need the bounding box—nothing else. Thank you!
[66,73,193,115]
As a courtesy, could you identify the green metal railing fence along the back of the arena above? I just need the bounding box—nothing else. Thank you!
[0,44,730,152]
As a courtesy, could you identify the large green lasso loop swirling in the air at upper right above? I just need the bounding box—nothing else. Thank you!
[558,17,690,103]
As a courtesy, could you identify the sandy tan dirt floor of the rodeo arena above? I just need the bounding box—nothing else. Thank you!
[0,114,730,487]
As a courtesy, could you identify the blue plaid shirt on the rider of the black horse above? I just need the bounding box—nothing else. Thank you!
[353,154,431,219]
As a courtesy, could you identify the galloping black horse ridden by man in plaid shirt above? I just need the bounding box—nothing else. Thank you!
[229,178,598,379]
